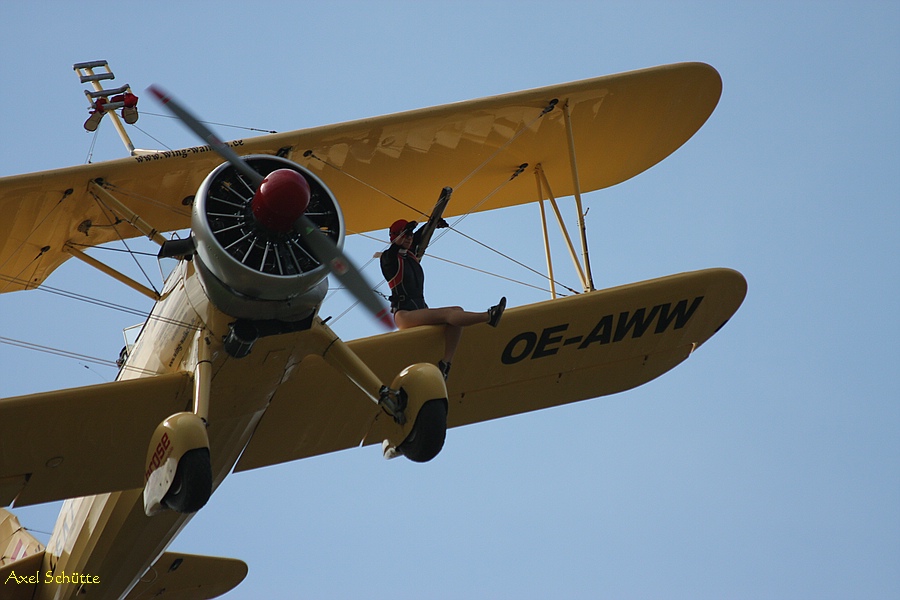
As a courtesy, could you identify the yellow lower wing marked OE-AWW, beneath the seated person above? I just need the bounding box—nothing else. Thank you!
[235,269,747,471]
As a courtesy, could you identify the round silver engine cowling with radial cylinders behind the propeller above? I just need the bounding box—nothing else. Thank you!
[191,155,344,321]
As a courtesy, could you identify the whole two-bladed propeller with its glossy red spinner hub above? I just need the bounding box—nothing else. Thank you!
[149,86,394,329]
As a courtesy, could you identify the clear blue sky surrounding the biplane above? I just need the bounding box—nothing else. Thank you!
[0,1,900,600]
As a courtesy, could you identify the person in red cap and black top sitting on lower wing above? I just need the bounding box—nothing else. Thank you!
[381,219,506,379]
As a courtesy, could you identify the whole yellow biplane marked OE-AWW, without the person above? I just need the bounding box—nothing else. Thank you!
[0,62,747,600]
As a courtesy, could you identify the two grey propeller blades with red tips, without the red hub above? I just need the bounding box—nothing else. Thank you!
[148,85,394,329]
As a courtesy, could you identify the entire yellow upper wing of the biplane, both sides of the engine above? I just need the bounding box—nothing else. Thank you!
[0,63,722,292]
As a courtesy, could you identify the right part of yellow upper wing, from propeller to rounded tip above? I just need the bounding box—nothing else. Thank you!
[253,63,722,233]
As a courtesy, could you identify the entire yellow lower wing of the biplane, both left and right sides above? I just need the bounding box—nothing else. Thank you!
[0,269,746,506]
